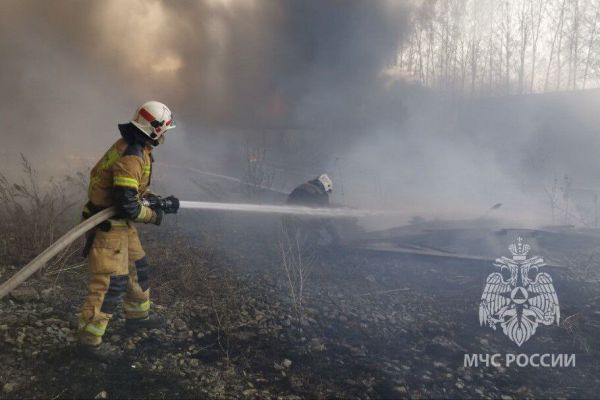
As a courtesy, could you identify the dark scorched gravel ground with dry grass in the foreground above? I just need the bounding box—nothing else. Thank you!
[0,223,600,399]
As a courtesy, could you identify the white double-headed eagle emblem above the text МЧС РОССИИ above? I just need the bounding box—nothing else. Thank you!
[479,237,560,346]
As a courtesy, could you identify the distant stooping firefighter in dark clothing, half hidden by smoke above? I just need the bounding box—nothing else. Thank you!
[283,174,340,248]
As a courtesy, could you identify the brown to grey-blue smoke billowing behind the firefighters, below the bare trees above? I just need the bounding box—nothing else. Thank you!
[0,0,600,227]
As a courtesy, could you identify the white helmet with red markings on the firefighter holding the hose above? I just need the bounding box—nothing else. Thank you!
[131,101,175,144]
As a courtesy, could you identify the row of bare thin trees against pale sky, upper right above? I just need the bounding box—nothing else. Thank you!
[390,0,600,95]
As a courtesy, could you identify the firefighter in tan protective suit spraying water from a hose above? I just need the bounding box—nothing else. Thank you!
[78,101,179,358]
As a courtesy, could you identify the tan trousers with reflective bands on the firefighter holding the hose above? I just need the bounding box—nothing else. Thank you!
[79,220,150,345]
